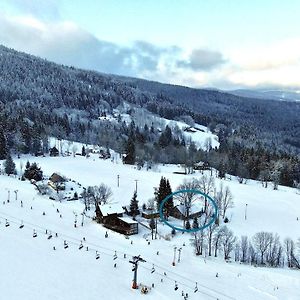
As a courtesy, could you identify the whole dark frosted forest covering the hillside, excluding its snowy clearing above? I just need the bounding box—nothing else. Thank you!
[0,46,300,187]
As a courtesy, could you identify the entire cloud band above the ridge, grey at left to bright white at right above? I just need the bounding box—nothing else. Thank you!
[0,11,300,89]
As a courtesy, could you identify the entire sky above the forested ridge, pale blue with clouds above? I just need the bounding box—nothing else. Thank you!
[0,0,300,90]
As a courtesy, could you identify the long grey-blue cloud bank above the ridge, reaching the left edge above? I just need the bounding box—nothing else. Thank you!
[0,14,185,77]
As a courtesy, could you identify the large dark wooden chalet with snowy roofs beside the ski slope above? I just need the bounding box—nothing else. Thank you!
[96,204,138,235]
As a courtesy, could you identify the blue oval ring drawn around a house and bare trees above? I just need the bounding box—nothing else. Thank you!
[159,189,218,232]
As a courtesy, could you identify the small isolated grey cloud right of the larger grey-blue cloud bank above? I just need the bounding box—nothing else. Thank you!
[178,49,225,71]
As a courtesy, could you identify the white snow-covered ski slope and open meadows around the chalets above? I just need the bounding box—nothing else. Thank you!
[0,155,300,300]
